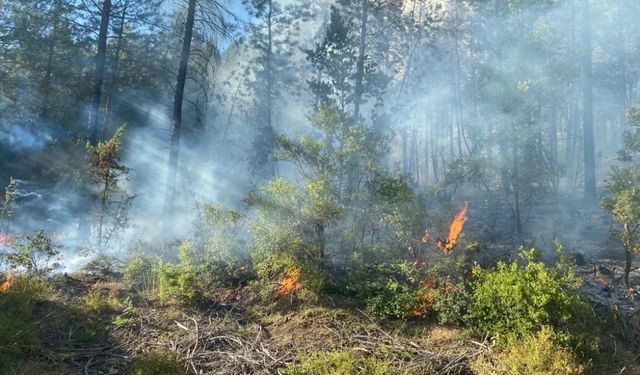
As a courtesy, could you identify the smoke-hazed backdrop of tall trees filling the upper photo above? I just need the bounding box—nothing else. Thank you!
[0,0,640,250]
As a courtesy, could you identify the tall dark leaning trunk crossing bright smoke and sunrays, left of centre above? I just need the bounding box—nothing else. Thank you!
[163,0,196,232]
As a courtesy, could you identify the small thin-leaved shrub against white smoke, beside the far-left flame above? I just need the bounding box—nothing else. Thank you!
[7,231,61,275]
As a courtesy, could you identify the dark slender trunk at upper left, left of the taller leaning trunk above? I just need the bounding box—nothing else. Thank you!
[89,0,111,145]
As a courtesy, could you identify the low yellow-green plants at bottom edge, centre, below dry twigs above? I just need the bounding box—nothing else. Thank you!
[283,350,390,375]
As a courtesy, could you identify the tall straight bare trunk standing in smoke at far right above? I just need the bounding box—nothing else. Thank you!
[582,0,596,201]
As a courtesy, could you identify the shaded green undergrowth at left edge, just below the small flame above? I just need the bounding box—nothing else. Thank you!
[0,275,52,362]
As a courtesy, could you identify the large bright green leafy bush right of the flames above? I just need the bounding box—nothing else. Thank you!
[465,250,596,351]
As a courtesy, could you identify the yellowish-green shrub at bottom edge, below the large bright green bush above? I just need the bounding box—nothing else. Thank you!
[471,326,585,375]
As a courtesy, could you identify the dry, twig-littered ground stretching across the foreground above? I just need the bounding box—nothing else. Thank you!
[8,265,640,375]
